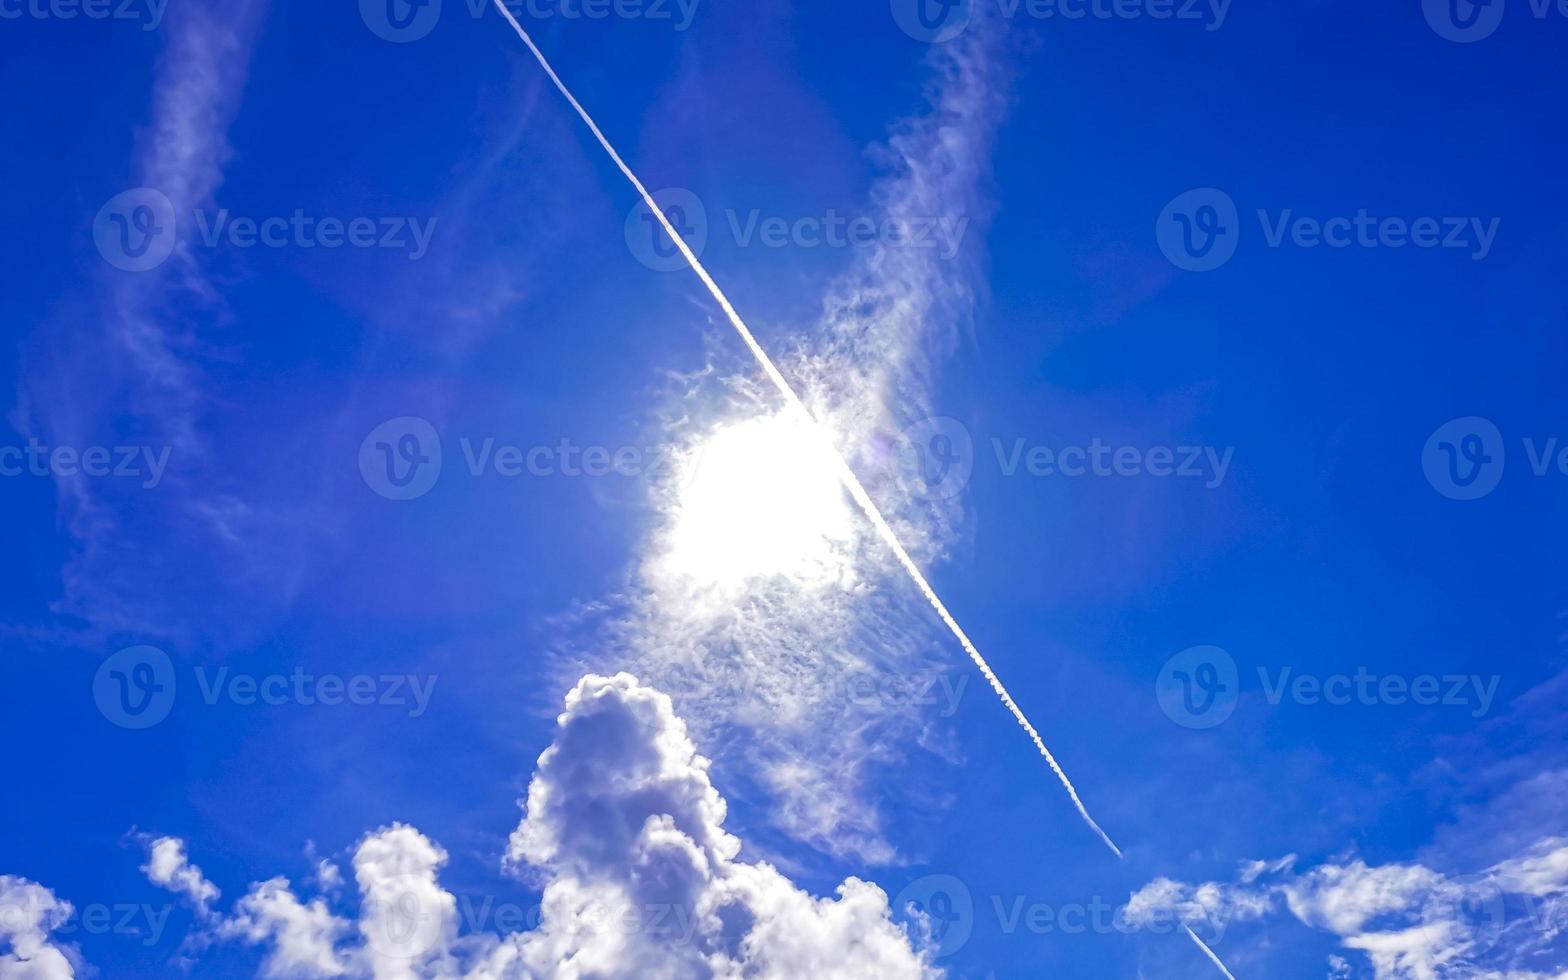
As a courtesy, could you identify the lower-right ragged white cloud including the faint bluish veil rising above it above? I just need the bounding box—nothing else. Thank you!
[1126,664,1568,980]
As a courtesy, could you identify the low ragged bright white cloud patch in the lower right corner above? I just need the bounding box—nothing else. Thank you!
[1126,837,1568,980]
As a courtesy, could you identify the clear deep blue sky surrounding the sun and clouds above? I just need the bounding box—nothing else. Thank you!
[0,0,1568,978]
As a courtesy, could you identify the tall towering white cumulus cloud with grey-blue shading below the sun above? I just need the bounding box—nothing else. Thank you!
[508,674,935,980]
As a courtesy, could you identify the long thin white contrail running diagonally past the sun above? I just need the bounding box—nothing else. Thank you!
[495,0,1128,852]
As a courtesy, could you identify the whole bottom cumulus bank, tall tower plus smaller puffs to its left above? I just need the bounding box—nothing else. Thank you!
[125,674,941,980]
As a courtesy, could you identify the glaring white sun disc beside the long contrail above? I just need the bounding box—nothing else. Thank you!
[665,412,855,590]
